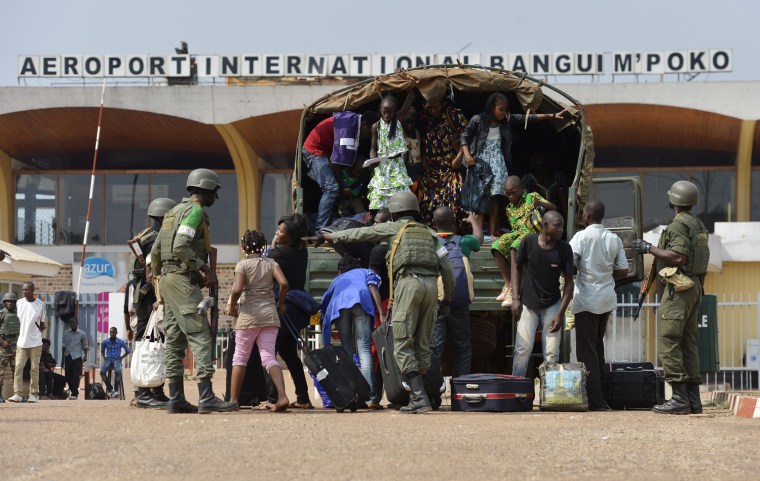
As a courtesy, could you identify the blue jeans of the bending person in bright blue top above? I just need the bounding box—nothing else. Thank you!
[335,304,380,403]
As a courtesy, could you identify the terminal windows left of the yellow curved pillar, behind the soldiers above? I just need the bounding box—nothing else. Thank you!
[14,173,238,245]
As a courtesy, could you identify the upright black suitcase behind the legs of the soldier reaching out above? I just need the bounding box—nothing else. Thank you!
[372,322,446,409]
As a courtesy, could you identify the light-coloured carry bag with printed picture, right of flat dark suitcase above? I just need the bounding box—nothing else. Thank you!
[538,362,588,411]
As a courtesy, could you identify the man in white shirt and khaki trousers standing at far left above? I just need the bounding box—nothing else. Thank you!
[8,282,46,403]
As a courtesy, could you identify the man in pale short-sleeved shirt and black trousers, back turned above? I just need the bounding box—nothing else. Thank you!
[570,200,628,411]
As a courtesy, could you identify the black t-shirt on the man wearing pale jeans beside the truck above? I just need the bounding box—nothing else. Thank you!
[517,234,573,309]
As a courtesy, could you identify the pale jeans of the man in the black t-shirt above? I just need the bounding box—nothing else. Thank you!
[512,301,562,377]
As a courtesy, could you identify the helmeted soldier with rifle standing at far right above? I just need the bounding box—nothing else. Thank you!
[634,180,710,414]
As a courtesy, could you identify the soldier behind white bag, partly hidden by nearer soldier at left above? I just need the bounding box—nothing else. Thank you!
[127,197,177,409]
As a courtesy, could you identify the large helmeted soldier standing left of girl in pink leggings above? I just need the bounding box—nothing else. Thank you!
[151,169,238,414]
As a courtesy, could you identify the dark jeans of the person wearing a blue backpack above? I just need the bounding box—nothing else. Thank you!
[430,307,472,377]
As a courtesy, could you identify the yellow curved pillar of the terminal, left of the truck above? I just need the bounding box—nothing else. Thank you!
[215,124,261,235]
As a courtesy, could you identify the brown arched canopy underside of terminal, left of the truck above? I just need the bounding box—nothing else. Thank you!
[0,107,300,170]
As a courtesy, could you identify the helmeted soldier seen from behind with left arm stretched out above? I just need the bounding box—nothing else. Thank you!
[320,191,454,413]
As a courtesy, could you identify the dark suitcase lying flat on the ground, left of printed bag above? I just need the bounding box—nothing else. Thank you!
[451,374,536,412]
